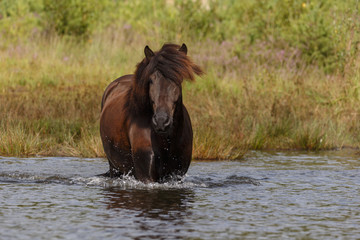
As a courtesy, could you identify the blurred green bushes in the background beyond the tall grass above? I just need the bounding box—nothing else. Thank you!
[0,0,360,73]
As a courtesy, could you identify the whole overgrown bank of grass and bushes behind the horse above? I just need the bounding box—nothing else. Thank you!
[0,0,360,159]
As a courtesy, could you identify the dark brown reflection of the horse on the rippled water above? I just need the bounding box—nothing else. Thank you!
[104,188,194,239]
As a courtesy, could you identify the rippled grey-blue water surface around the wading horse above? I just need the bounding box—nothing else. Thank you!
[0,152,360,239]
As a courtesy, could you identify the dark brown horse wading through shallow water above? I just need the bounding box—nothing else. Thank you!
[100,44,202,182]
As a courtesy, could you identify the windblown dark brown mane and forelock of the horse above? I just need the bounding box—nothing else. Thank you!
[135,43,203,87]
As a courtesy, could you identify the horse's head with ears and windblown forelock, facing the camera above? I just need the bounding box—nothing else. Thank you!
[144,44,202,134]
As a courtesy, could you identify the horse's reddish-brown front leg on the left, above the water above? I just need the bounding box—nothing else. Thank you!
[130,125,158,183]
